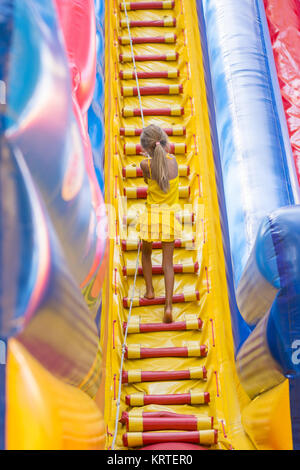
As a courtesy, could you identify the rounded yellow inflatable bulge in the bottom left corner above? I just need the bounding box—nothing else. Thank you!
[6,340,105,450]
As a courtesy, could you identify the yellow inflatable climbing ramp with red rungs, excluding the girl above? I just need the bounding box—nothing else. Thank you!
[99,0,253,449]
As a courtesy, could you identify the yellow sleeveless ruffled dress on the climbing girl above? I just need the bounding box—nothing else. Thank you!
[136,155,182,242]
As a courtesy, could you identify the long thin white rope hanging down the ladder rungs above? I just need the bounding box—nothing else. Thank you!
[111,0,145,450]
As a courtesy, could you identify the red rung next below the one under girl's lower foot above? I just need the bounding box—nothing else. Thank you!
[125,342,207,359]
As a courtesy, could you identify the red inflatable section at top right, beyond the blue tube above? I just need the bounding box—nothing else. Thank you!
[264,0,300,185]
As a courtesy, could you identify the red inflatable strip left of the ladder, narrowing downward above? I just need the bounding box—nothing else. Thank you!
[55,0,107,288]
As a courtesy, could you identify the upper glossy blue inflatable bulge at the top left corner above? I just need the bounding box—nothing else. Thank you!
[5,0,106,283]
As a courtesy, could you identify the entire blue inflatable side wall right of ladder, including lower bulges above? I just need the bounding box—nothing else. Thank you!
[198,0,300,448]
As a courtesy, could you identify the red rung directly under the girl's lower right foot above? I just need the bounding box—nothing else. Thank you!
[123,315,203,334]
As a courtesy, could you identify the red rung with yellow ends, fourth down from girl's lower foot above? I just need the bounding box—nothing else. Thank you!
[125,390,210,406]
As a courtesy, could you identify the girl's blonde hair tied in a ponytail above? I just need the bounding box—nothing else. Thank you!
[141,124,170,193]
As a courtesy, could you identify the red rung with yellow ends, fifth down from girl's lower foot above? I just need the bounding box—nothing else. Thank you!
[126,415,213,432]
